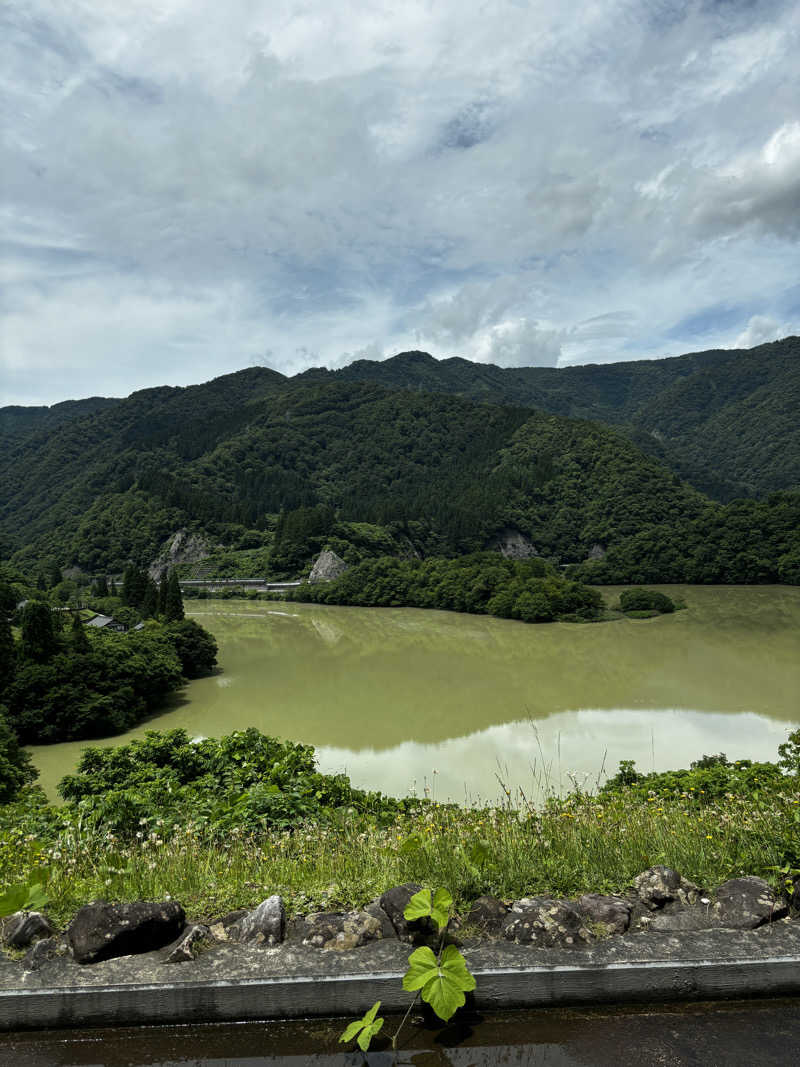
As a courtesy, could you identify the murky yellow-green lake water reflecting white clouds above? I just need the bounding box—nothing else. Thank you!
[28,586,800,800]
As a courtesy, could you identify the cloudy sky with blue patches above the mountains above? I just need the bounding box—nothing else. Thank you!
[0,0,800,404]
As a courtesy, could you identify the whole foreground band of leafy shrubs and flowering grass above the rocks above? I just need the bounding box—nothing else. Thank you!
[0,731,800,921]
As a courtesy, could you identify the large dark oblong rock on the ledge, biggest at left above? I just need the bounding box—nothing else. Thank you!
[67,901,186,964]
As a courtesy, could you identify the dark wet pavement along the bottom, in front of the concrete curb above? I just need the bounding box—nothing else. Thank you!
[0,998,800,1067]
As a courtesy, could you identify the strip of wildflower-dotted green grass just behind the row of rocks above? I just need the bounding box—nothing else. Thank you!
[0,777,800,923]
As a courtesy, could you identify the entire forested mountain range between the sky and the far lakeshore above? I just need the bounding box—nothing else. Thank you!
[0,338,800,582]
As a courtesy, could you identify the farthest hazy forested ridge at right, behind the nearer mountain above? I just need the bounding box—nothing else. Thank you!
[300,337,800,499]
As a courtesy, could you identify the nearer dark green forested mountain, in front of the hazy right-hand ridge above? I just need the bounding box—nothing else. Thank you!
[0,368,708,571]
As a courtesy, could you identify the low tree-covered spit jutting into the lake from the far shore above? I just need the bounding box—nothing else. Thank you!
[289,553,603,622]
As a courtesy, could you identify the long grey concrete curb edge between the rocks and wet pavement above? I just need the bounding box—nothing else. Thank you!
[0,955,800,1031]
